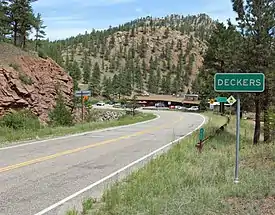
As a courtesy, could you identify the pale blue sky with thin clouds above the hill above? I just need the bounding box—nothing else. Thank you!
[33,0,238,40]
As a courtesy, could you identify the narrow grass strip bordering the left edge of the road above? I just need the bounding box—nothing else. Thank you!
[0,113,156,147]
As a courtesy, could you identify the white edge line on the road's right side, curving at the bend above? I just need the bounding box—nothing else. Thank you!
[34,113,206,215]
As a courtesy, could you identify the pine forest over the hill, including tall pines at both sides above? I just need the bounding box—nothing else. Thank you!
[0,0,275,144]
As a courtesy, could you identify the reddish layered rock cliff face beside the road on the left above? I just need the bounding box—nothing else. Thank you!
[0,56,73,122]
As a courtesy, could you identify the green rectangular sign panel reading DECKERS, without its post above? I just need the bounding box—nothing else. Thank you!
[214,73,265,93]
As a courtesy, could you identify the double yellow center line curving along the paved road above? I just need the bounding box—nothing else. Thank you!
[0,117,183,173]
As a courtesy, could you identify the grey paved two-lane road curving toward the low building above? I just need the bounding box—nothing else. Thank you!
[0,111,204,215]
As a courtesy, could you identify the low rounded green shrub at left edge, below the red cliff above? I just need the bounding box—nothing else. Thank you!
[0,110,40,130]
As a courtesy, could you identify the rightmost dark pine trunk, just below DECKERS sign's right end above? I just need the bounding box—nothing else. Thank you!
[263,81,270,142]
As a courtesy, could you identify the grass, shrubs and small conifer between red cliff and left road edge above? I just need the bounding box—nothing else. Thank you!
[0,96,156,147]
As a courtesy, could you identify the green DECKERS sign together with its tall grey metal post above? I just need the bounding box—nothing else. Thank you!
[214,73,265,183]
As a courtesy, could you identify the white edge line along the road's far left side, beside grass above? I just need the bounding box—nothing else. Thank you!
[0,113,160,151]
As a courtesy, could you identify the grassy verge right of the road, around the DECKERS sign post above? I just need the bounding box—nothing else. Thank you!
[68,111,275,215]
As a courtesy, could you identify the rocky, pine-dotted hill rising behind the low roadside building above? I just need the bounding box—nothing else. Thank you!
[47,14,214,96]
